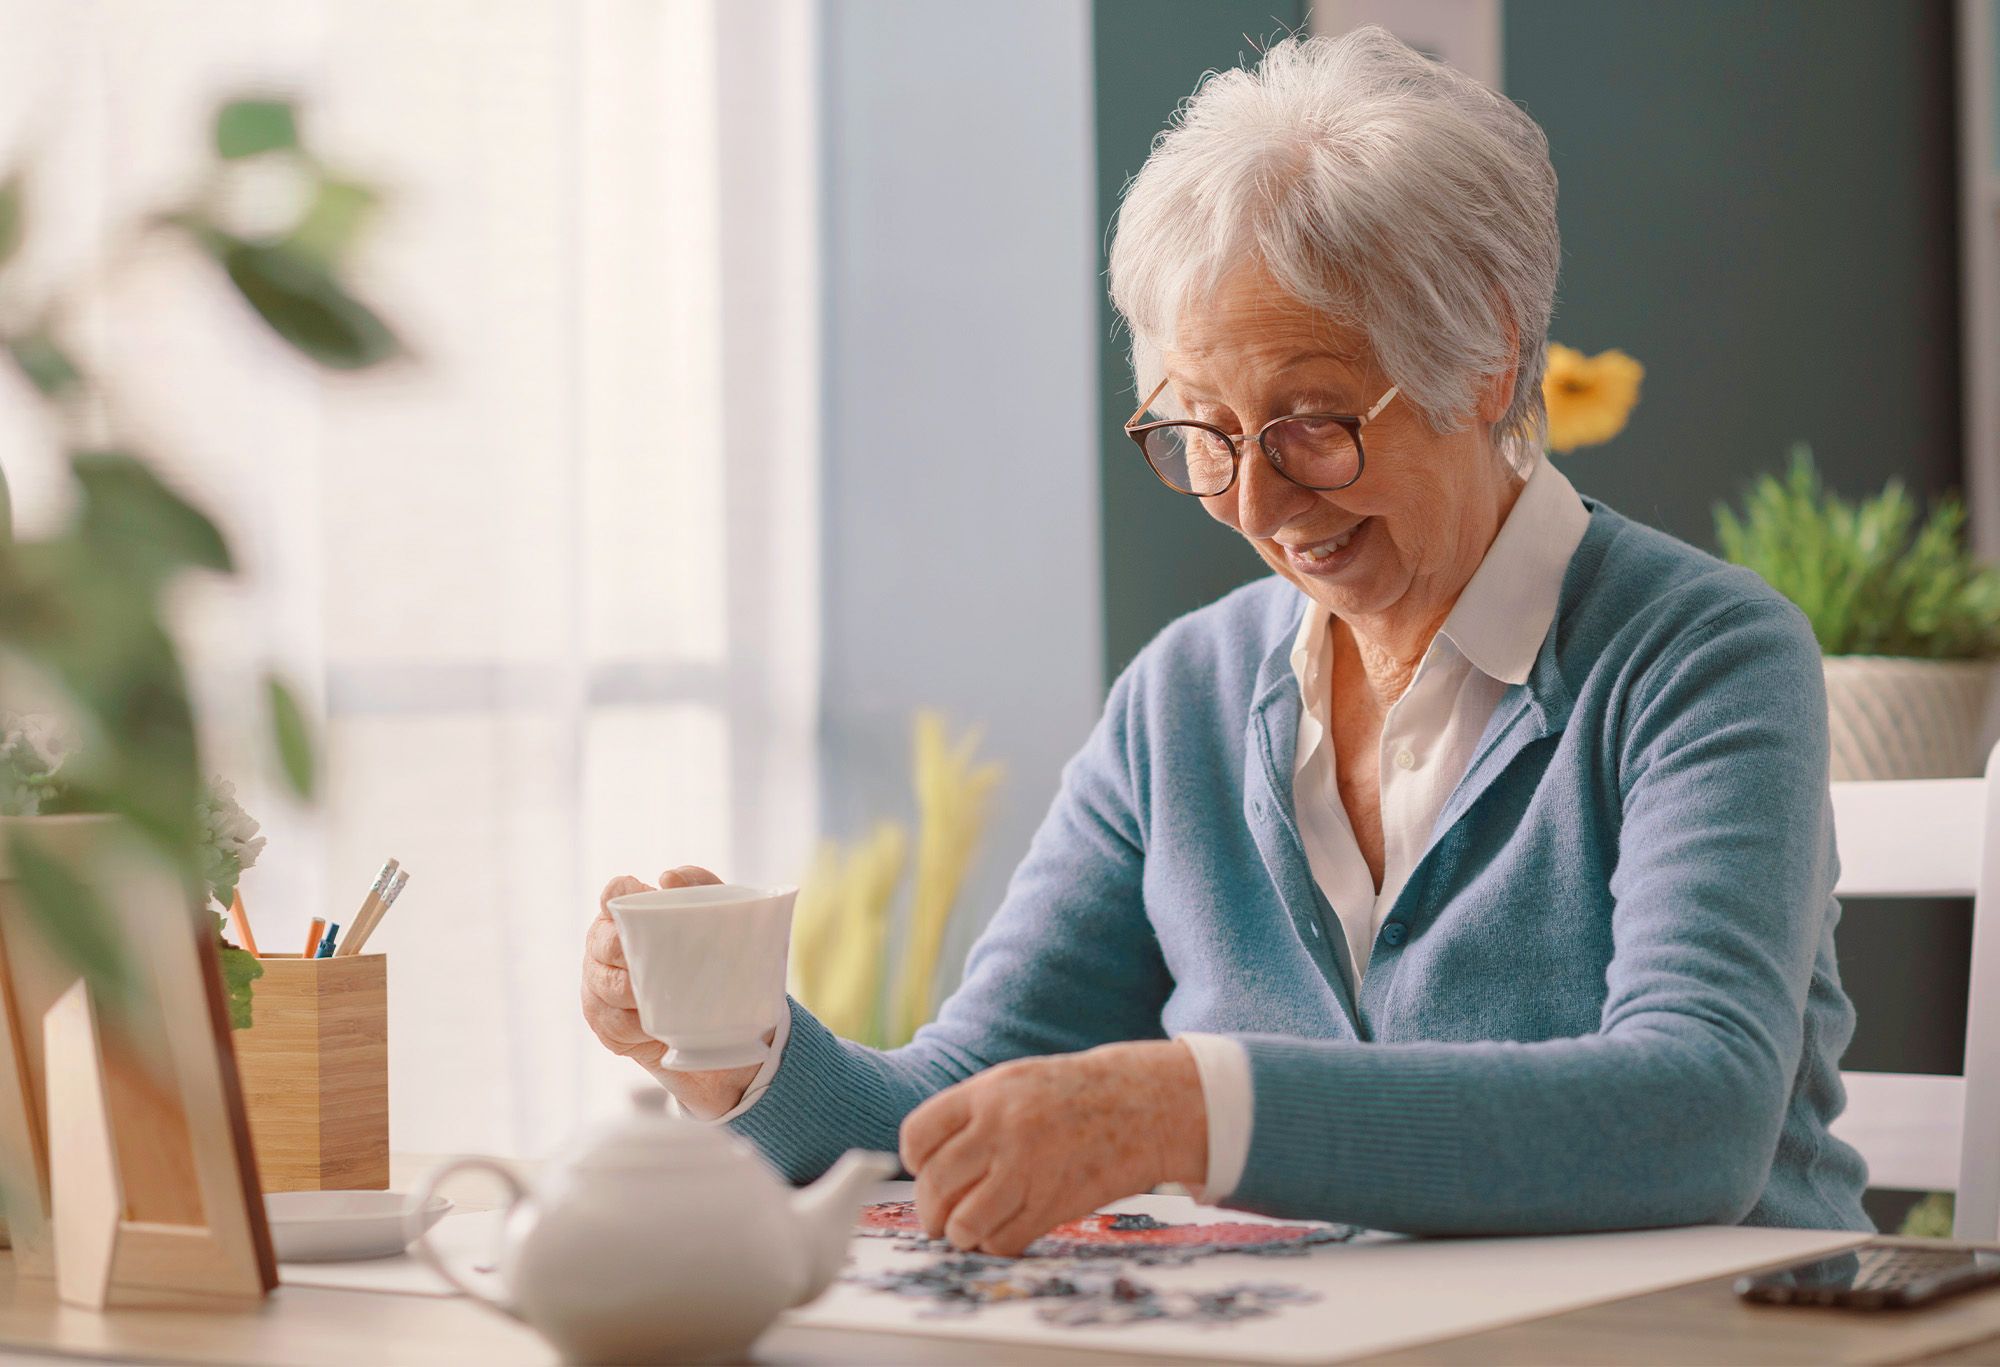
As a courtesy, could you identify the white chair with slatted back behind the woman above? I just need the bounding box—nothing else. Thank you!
[1834,745,2000,1241]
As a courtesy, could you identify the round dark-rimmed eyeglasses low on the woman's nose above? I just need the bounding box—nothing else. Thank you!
[1124,380,1398,498]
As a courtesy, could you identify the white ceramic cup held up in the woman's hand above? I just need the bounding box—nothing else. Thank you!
[610,883,798,1069]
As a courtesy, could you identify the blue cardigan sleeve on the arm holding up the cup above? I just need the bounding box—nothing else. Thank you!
[728,662,1172,1181]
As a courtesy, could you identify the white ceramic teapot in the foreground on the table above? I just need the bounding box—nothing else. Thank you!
[410,1087,900,1363]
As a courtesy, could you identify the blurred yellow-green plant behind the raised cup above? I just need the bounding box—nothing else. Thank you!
[792,711,1002,1049]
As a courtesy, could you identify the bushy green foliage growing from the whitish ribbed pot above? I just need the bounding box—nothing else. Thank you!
[1716,444,2000,660]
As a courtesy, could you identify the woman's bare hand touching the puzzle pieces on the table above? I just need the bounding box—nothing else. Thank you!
[902,1041,1208,1257]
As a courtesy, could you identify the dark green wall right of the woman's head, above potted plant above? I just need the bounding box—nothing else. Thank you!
[1504,0,1960,546]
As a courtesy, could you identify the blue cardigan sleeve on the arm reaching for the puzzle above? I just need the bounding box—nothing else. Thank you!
[1228,598,1836,1233]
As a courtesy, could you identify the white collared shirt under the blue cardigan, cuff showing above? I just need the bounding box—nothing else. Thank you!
[1176,460,1590,1201]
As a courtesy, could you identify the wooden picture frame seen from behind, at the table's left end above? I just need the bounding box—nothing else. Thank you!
[0,815,278,1307]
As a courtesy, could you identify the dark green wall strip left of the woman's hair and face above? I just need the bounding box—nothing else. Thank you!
[1094,0,1306,685]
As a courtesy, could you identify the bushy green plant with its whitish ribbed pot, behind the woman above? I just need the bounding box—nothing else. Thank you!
[1716,444,2000,779]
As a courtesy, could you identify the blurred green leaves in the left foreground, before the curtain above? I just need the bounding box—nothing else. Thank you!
[0,96,402,1007]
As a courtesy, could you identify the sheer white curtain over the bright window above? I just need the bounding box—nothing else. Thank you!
[0,0,818,1153]
